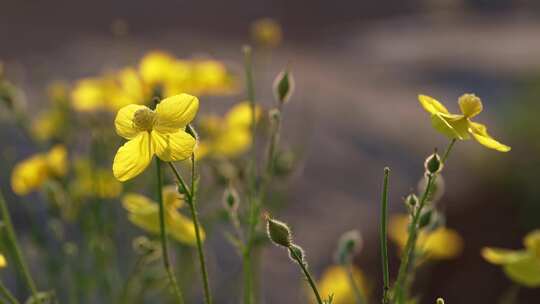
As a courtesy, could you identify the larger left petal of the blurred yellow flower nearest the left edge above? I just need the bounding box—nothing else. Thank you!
[11,154,48,195]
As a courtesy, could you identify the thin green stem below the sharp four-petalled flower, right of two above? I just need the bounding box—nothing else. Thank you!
[188,154,212,304]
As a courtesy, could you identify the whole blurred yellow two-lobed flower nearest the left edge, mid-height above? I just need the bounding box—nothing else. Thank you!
[11,145,68,195]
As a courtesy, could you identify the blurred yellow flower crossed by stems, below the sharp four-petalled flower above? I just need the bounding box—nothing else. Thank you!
[122,186,205,246]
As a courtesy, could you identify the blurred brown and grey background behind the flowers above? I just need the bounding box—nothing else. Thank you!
[0,0,540,303]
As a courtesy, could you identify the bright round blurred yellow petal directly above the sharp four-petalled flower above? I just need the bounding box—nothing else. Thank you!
[139,51,174,85]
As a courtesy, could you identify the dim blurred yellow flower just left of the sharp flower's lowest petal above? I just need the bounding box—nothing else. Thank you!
[70,159,122,198]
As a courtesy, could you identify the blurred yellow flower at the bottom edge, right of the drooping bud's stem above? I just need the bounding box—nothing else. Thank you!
[318,265,368,304]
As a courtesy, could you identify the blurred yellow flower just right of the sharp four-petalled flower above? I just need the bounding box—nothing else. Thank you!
[197,101,262,158]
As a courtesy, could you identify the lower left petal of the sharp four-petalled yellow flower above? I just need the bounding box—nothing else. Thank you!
[113,132,154,182]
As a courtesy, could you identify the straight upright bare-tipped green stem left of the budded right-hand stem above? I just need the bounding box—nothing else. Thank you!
[380,167,390,304]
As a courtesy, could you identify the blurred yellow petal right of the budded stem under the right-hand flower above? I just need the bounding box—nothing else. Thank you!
[419,227,463,259]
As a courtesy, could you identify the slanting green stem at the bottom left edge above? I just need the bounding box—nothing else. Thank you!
[0,192,38,299]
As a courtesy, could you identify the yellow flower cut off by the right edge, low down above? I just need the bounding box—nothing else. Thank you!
[482,229,540,287]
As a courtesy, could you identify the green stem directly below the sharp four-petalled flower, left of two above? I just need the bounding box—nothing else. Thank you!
[156,157,184,304]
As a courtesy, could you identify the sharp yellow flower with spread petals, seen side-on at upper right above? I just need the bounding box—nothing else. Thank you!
[418,94,510,152]
